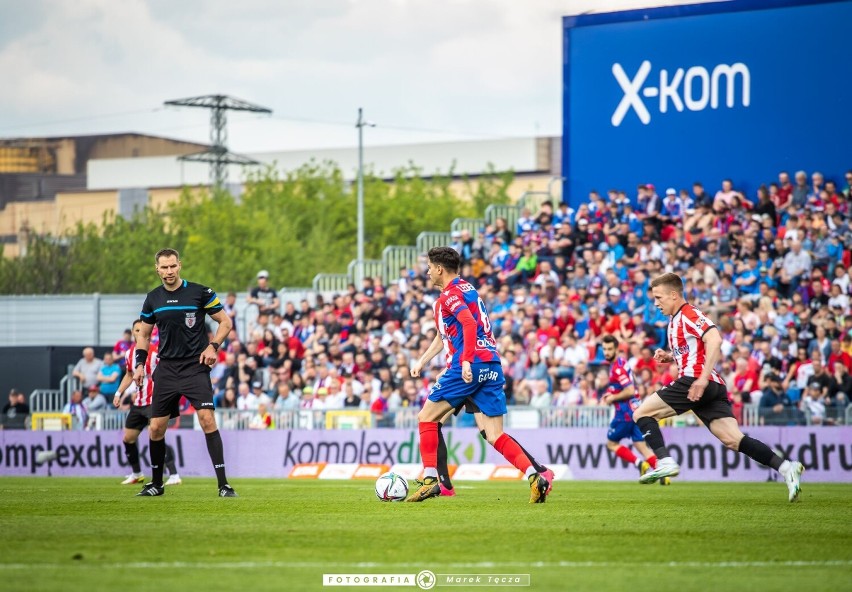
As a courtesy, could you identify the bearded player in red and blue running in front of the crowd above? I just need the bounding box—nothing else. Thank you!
[601,335,671,485]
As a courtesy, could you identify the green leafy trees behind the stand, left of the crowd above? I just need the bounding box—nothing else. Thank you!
[0,161,512,294]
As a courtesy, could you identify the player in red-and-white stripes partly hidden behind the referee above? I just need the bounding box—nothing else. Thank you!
[112,319,181,485]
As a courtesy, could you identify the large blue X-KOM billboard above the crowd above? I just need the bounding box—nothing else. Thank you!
[562,0,852,205]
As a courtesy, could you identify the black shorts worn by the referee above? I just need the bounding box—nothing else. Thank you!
[151,357,213,417]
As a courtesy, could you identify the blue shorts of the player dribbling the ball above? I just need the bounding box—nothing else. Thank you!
[429,362,506,417]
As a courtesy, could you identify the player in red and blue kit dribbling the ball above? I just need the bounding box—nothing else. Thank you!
[408,247,549,503]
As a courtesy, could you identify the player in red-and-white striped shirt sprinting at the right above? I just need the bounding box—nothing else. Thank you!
[633,273,804,502]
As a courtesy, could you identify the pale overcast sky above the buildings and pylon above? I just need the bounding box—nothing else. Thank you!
[0,0,704,152]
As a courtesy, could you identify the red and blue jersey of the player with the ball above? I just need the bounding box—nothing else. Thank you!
[433,278,500,368]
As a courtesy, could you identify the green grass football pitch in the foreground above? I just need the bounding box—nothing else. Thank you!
[0,474,852,592]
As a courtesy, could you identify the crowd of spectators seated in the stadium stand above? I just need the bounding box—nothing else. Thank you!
[38,166,852,428]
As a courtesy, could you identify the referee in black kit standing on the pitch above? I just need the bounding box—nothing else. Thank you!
[133,249,237,497]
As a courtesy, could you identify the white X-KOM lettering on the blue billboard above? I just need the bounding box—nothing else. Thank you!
[612,60,751,127]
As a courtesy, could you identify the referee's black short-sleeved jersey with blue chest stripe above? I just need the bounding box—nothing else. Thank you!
[139,280,222,360]
